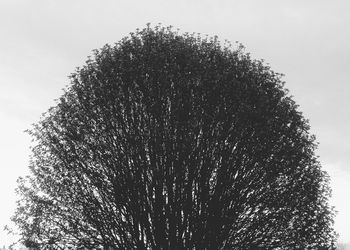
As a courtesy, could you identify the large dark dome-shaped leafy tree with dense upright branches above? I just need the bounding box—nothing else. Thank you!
[13,26,335,249]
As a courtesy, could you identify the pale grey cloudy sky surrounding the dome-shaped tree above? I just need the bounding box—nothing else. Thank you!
[0,0,350,247]
